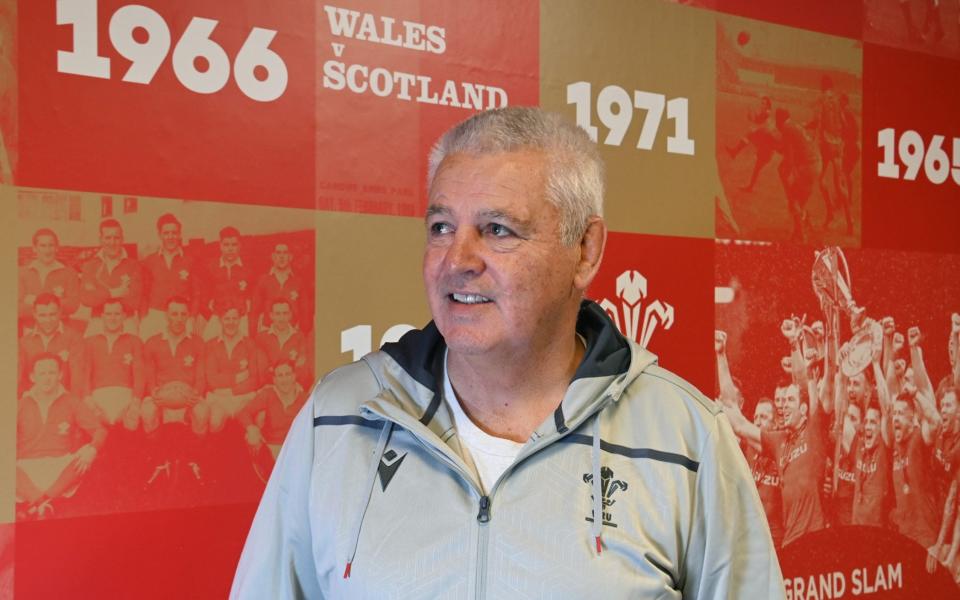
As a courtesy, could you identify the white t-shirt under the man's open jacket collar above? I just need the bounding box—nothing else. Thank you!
[443,354,524,493]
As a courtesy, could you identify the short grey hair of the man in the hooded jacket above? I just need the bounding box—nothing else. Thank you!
[427,106,604,246]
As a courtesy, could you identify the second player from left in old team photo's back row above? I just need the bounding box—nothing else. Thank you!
[80,219,143,336]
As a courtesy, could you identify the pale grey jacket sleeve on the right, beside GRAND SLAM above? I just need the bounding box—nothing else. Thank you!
[682,414,785,600]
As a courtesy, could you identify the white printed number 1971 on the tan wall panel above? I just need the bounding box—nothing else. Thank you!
[567,81,695,156]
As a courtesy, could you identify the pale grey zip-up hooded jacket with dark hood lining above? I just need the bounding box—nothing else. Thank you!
[230,302,784,599]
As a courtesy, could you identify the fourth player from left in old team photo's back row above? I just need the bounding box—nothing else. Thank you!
[200,227,256,341]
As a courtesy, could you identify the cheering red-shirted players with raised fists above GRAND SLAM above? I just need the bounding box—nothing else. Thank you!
[715,300,960,583]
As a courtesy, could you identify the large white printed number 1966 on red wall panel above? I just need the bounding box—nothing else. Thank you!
[57,0,287,102]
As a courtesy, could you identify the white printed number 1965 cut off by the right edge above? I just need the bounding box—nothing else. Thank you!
[877,127,960,185]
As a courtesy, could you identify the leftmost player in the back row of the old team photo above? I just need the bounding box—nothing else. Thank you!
[17,227,80,328]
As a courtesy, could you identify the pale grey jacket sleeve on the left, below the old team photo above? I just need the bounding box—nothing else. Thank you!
[230,400,323,600]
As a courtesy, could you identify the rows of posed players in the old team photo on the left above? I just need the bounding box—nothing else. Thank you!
[16,213,313,519]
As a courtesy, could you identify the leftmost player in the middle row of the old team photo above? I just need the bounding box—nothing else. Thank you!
[18,292,84,397]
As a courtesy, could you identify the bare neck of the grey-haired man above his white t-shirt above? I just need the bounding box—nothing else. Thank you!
[447,329,585,442]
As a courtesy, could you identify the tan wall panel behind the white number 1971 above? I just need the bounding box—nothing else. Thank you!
[540,1,718,237]
